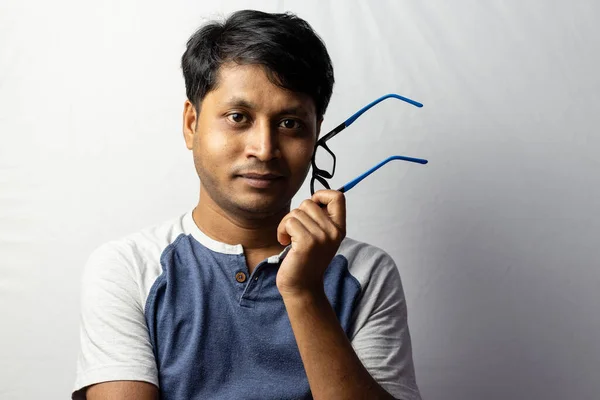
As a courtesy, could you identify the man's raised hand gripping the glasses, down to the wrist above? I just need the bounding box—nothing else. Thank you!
[277,190,346,296]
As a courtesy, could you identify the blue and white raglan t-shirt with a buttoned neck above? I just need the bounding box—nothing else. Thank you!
[73,211,420,400]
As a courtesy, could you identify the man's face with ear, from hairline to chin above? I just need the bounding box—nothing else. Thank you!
[184,64,321,218]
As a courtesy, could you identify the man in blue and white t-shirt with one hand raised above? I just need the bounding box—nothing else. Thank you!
[73,11,420,400]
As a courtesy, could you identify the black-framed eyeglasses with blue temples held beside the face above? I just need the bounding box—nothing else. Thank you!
[310,93,428,195]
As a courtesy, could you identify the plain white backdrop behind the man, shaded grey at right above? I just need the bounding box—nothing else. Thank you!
[0,0,600,400]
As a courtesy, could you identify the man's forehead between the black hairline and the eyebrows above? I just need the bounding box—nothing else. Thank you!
[204,63,316,116]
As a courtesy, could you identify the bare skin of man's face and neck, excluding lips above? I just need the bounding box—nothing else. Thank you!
[188,64,321,272]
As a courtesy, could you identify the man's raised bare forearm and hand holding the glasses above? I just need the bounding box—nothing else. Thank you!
[277,190,408,399]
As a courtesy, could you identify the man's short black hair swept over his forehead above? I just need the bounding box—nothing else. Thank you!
[181,10,334,118]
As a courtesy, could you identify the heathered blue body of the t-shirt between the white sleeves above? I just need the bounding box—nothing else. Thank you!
[145,234,361,400]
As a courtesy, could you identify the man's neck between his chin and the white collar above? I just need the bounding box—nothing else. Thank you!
[192,188,289,253]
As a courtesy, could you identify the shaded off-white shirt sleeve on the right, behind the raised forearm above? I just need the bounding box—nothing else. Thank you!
[351,249,421,400]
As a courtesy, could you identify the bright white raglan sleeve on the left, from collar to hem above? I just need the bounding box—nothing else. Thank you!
[73,217,184,398]
